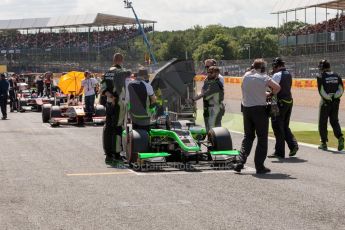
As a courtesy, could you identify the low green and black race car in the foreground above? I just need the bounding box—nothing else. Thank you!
[123,118,239,170]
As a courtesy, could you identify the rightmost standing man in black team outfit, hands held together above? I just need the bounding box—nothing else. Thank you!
[317,60,344,151]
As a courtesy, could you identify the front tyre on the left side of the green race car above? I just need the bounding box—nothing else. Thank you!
[126,129,150,164]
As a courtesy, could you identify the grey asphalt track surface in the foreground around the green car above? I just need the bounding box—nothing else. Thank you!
[0,110,345,230]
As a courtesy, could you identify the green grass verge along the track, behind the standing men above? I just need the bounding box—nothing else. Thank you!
[196,110,345,148]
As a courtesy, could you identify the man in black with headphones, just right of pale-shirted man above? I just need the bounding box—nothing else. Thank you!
[271,57,298,158]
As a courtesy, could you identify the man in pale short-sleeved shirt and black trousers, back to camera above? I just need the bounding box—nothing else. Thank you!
[234,59,280,174]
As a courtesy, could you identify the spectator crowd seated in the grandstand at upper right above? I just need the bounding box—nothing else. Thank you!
[291,15,345,35]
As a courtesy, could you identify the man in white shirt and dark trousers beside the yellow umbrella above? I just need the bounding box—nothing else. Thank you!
[78,71,98,121]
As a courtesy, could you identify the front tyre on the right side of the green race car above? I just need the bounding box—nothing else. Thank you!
[208,127,232,151]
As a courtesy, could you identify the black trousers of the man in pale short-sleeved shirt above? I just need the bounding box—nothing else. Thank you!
[240,106,269,170]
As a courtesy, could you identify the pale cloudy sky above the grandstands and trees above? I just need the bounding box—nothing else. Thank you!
[0,0,338,31]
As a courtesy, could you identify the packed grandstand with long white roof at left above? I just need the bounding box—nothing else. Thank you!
[0,13,156,72]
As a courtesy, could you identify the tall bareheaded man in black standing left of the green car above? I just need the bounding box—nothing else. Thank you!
[101,53,131,164]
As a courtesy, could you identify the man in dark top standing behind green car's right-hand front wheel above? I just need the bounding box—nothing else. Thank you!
[192,66,225,132]
